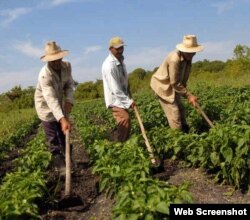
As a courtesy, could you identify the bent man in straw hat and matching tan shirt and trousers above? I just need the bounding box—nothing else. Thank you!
[150,35,204,132]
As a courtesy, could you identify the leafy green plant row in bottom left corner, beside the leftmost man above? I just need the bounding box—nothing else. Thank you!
[0,128,51,219]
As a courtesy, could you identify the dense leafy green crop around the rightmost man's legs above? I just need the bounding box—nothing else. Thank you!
[135,85,250,190]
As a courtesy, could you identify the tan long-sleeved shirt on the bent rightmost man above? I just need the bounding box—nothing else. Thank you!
[150,50,191,103]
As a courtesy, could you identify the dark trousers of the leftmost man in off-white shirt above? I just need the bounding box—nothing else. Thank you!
[42,121,65,154]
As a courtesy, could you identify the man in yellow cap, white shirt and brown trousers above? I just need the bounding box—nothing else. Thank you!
[102,37,135,142]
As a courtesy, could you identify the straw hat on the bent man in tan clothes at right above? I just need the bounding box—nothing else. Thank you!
[176,35,204,53]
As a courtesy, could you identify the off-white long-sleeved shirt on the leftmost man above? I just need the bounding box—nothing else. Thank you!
[35,62,74,121]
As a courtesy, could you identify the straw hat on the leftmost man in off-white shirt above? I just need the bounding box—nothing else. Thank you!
[40,41,68,62]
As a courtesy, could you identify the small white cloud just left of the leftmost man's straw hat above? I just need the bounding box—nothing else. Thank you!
[13,41,44,58]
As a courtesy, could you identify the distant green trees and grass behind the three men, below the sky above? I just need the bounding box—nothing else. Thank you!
[0,45,250,112]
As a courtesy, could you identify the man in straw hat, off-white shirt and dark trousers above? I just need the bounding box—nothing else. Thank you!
[35,41,74,172]
